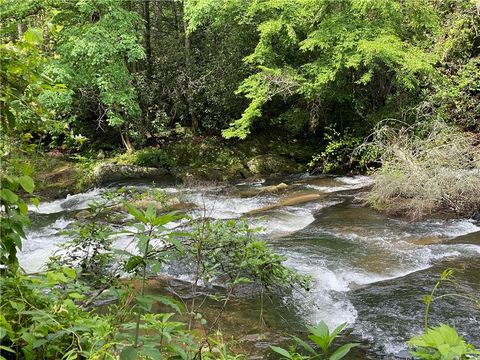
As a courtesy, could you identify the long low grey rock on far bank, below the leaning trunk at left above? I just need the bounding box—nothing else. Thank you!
[93,163,169,184]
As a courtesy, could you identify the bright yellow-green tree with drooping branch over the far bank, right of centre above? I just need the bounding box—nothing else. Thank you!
[216,0,438,138]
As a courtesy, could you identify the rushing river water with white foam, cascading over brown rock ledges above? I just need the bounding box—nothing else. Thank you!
[20,176,480,359]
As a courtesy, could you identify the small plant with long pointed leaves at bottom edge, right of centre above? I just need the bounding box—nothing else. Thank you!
[270,321,358,360]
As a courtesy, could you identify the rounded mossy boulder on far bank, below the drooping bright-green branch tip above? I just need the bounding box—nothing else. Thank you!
[247,154,301,176]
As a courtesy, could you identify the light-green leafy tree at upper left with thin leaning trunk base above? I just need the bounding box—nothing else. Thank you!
[51,0,145,150]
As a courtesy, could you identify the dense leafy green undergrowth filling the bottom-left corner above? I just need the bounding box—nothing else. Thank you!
[0,267,125,360]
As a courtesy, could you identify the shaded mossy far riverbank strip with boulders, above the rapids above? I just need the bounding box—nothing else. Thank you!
[28,136,316,200]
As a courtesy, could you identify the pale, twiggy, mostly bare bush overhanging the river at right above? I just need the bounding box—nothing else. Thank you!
[370,121,480,218]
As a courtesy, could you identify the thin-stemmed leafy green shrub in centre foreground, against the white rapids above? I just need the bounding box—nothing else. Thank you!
[184,218,310,333]
